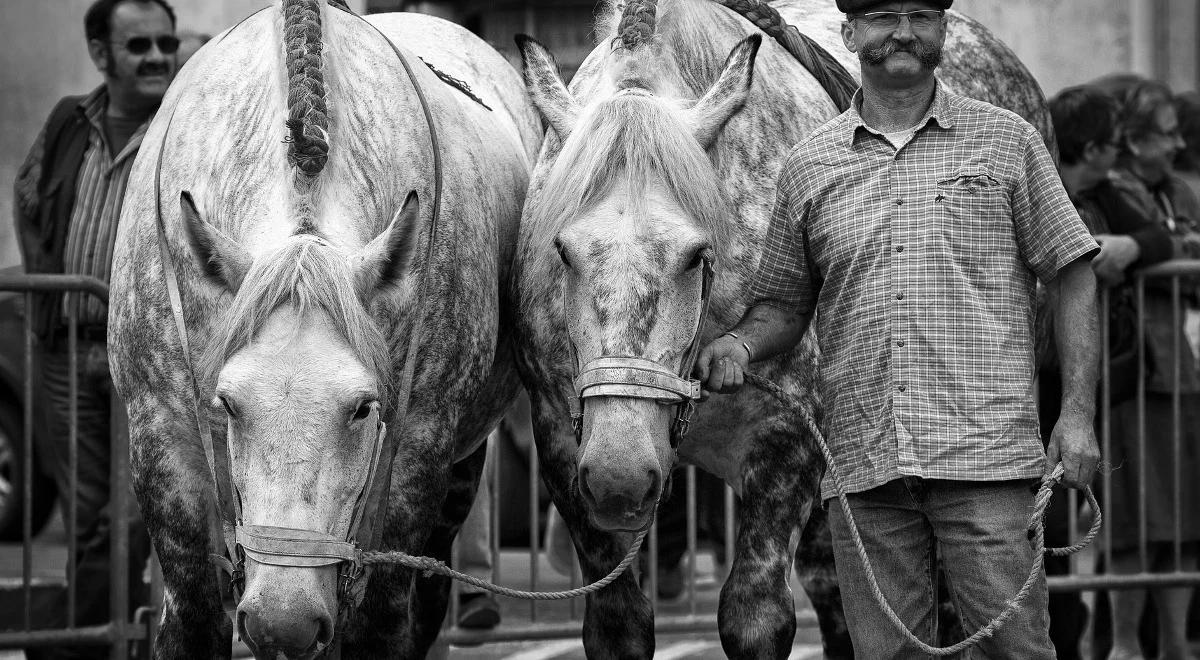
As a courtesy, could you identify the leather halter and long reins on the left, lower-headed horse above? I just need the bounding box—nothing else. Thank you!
[155,5,443,629]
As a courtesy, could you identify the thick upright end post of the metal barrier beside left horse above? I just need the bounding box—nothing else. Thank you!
[109,392,131,660]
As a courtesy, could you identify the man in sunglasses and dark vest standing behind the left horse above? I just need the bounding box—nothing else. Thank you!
[16,0,179,658]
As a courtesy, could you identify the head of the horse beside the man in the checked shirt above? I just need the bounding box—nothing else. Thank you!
[518,18,761,529]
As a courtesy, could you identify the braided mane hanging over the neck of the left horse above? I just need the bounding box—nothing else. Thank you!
[283,0,329,234]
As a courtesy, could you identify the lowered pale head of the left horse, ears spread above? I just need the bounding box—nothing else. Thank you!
[180,192,419,658]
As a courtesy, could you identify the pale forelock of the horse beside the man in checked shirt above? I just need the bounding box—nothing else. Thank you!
[529,90,730,266]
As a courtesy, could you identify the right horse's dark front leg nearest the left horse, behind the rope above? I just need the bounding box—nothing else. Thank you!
[529,391,654,660]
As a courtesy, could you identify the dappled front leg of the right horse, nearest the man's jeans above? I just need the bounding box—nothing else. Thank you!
[718,424,821,658]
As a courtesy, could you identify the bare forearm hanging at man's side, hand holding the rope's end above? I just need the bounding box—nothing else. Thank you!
[1050,259,1100,420]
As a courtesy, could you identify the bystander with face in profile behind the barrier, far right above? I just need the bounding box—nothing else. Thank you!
[1098,76,1200,660]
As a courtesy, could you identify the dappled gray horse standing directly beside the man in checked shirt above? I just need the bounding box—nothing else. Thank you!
[516,0,1050,658]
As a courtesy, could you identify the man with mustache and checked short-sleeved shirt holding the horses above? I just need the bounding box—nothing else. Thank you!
[697,0,1099,659]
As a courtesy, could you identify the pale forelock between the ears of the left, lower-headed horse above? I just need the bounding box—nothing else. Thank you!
[200,235,395,402]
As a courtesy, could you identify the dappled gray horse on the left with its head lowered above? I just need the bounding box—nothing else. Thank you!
[110,0,541,660]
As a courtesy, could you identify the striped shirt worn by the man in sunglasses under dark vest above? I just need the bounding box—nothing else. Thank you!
[62,85,150,325]
